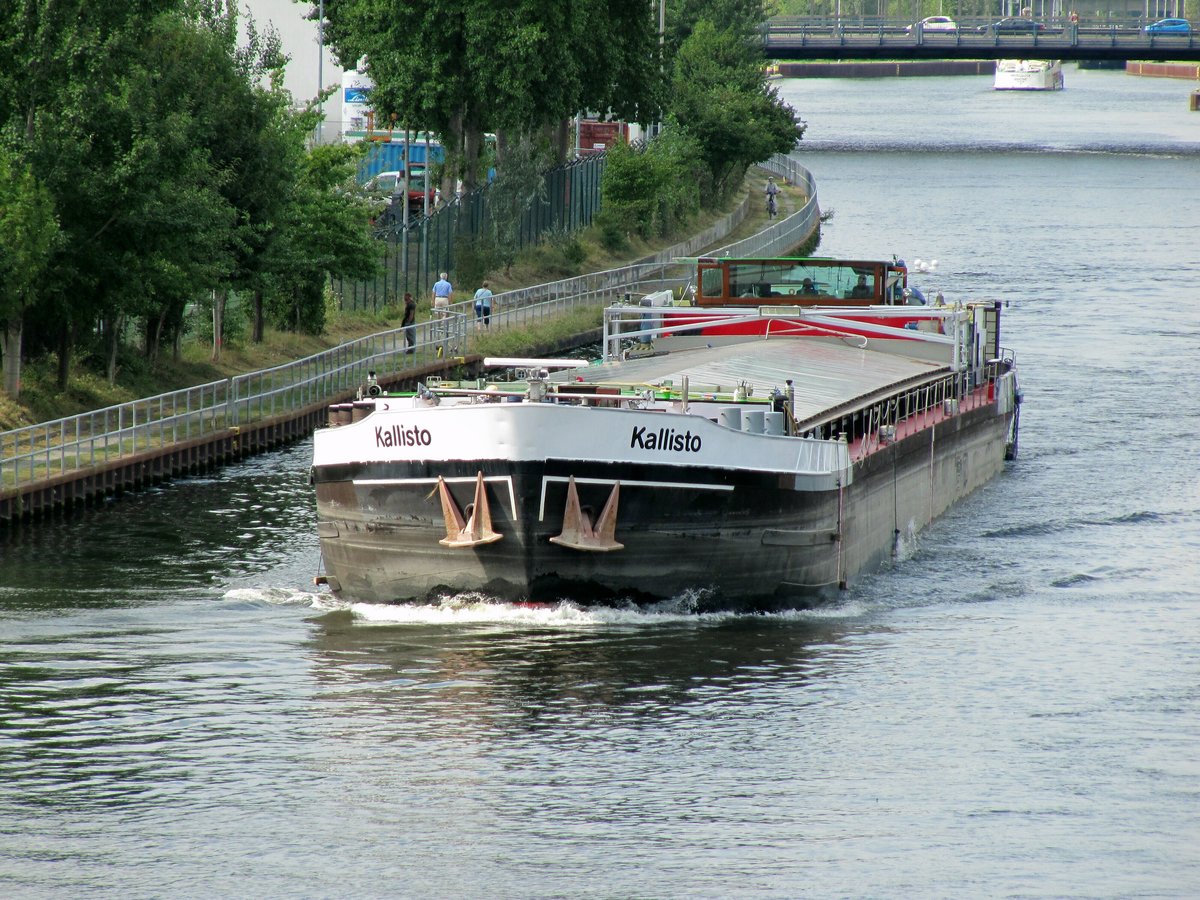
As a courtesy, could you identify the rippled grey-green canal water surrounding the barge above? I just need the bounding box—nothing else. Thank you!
[0,66,1200,900]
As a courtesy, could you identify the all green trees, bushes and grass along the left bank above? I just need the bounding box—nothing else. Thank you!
[0,0,803,428]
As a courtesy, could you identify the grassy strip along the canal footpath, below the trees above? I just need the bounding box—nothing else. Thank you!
[0,170,800,431]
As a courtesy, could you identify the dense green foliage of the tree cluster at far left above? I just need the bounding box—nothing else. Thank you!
[0,0,374,393]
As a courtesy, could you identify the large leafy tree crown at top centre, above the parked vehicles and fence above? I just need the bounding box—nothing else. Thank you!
[314,0,661,188]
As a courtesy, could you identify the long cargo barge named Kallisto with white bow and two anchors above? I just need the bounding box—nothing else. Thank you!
[312,258,1021,610]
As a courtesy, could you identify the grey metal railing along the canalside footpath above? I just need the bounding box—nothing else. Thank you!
[0,157,820,491]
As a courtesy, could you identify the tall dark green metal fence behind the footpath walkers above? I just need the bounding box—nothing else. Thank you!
[331,154,605,311]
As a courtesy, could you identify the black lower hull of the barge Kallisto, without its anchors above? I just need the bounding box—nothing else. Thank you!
[314,404,1010,610]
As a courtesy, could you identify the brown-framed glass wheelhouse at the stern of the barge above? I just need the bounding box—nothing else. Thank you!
[696,257,920,306]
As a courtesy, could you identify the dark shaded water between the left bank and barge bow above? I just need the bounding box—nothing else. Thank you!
[0,443,319,611]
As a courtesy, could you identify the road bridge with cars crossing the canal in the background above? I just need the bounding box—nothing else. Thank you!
[763,17,1200,62]
